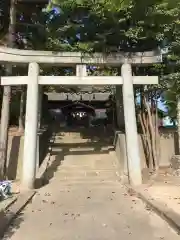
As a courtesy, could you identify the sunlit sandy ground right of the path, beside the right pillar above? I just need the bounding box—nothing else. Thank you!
[129,173,180,234]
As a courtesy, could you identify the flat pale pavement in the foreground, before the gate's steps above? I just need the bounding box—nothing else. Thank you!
[3,181,179,240]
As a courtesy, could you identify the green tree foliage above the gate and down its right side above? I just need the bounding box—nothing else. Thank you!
[0,0,180,120]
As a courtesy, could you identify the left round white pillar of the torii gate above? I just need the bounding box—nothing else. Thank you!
[22,63,39,189]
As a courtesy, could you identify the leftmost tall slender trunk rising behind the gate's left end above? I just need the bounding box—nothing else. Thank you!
[0,0,16,179]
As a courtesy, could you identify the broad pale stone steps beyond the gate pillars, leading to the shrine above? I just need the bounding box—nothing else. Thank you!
[47,129,120,186]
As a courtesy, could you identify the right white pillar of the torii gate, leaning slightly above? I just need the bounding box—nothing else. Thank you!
[121,63,142,185]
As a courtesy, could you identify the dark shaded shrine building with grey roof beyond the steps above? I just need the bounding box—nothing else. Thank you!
[46,91,117,128]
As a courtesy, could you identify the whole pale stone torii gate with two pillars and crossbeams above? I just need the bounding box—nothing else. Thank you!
[0,48,161,189]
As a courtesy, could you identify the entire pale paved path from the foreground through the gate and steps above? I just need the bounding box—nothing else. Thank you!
[3,130,179,240]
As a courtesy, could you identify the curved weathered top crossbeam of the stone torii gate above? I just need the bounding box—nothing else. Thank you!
[0,47,162,66]
